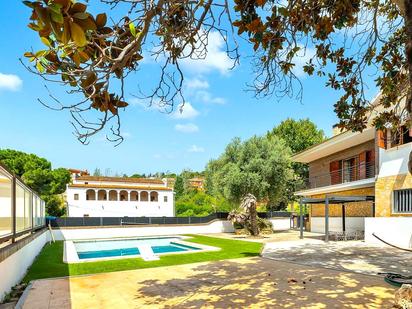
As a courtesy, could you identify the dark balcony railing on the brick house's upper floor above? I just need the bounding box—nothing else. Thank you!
[299,162,375,190]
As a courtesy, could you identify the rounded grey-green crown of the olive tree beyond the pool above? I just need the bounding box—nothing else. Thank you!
[206,136,293,205]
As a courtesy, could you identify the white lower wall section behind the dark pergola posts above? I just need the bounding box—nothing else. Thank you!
[310,217,365,233]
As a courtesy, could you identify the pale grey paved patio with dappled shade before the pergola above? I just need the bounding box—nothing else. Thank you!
[262,239,412,275]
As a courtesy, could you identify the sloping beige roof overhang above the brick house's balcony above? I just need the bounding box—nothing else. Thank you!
[292,127,375,163]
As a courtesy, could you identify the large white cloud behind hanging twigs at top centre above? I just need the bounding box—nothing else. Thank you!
[181,31,233,74]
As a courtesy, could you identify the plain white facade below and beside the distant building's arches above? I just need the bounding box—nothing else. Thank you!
[67,188,174,217]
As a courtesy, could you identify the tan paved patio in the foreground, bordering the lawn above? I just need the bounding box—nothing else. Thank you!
[23,257,394,309]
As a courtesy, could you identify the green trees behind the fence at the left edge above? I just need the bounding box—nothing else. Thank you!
[0,149,70,216]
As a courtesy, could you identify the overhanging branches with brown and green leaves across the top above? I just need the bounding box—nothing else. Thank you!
[24,0,412,143]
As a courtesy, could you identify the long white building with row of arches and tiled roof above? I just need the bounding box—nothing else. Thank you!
[66,174,175,217]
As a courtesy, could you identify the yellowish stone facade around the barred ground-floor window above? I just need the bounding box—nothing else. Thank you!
[375,174,412,217]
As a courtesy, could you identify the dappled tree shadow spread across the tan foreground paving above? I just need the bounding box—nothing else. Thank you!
[135,258,394,308]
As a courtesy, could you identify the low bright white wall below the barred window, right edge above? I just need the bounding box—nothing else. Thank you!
[365,217,412,248]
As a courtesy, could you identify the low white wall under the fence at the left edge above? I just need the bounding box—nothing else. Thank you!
[0,231,49,301]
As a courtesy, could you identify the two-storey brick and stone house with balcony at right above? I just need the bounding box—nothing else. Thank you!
[293,100,412,245]
